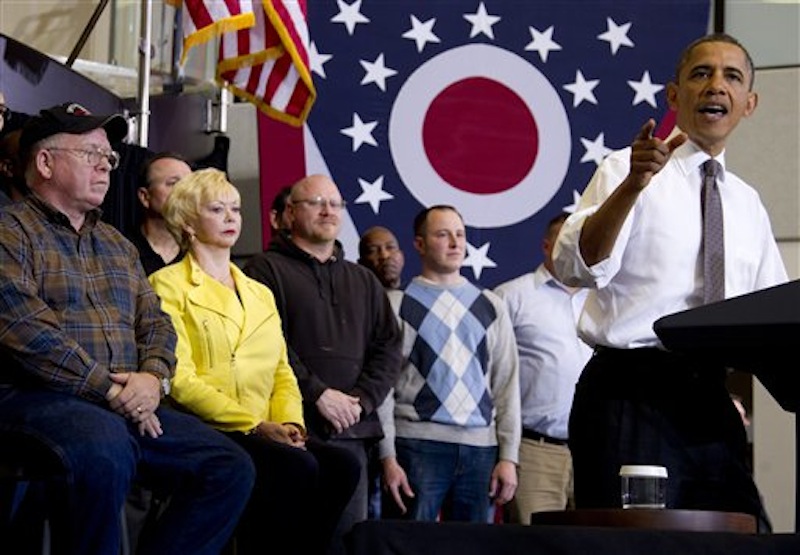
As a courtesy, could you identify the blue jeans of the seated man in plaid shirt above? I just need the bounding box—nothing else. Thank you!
[0,387,255,555]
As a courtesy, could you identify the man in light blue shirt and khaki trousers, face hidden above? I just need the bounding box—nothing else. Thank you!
[494,213,592,524]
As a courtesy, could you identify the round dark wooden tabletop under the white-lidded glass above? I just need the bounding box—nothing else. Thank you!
[531,509,756,534]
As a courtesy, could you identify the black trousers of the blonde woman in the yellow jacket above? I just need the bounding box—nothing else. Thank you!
[230,433,361,555]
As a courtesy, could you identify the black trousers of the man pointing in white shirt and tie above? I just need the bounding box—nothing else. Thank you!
[569,348,771,532]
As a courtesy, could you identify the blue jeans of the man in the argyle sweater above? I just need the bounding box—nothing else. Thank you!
[395,438,497,522]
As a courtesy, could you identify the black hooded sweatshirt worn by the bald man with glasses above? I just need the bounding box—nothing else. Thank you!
[244,234,402,439]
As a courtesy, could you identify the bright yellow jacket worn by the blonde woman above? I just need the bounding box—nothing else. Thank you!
[150,254,305,432]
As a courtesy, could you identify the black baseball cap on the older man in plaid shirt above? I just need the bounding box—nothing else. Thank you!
[19,102,128,160]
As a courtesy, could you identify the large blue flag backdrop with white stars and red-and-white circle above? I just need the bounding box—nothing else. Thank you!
[258,0,710,287]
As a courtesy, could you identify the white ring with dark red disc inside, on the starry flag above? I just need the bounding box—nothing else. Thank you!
[389,44,572,228]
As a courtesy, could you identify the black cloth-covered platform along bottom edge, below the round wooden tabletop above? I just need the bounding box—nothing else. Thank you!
[347,520,800,555]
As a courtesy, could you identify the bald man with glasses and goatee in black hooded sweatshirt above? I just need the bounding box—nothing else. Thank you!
[244,175,400,553]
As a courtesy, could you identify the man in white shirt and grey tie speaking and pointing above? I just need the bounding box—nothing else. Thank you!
[554,34,787,532]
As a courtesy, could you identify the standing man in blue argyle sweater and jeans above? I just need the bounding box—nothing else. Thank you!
[379,206,522,522]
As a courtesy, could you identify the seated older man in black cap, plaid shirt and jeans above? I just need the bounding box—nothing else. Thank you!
[0,103,254,555]
